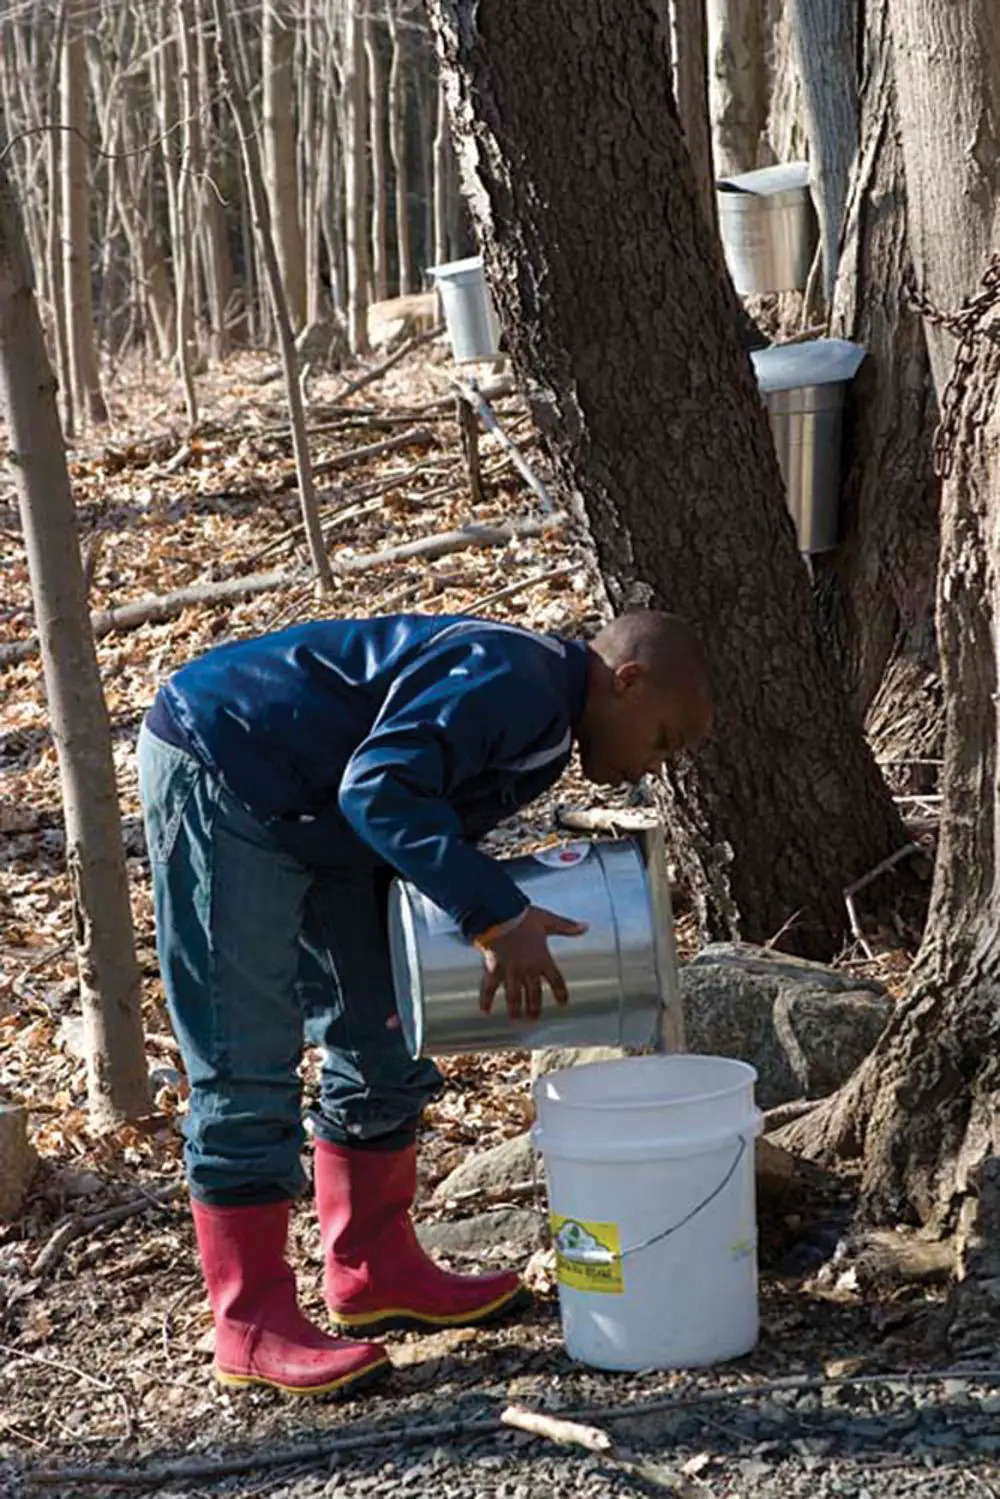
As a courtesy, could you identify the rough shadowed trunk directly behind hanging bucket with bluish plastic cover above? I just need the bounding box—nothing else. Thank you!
[816,6,942,725]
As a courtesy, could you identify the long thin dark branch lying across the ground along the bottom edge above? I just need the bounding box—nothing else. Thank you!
[21,1367,1000,1489]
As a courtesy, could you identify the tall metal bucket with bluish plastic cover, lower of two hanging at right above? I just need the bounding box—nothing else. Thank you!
[750,339,865,553]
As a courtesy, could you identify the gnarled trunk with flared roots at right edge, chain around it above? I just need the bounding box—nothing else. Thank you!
[787,264,1000,1253]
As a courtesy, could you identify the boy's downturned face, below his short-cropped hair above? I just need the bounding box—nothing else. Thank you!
[579,661,714,785]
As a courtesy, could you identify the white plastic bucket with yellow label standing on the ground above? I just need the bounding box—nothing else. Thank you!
[534,1055,762,1370]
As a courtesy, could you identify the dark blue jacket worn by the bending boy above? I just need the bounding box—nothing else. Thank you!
[147,615,586,937]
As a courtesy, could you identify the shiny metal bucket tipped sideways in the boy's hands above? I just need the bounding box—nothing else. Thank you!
[388,829,684,1057]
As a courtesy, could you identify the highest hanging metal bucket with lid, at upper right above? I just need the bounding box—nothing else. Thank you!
[715,162,819,297]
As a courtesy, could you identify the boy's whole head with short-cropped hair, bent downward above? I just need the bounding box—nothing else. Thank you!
[577,609,714,785]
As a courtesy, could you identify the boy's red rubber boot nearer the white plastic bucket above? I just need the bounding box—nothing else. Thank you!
[315,1139,529,1337]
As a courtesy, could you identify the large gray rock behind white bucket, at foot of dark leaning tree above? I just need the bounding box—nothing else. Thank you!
[681,943,892,1109]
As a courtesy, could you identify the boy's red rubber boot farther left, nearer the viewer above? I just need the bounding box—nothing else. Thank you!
[190,1201,390,1396]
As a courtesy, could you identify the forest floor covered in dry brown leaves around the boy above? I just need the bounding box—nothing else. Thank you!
[0,340,983,1499]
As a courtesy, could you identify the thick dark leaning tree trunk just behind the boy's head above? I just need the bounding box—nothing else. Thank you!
[430,0,903,953]
